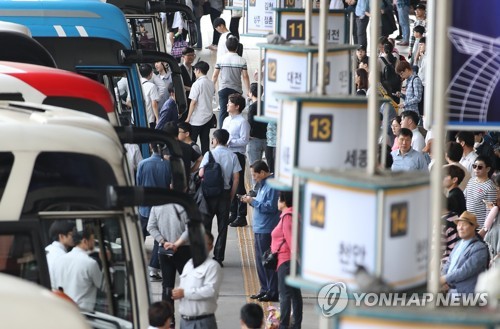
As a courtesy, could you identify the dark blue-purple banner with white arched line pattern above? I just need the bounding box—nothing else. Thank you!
[448,0,500,127]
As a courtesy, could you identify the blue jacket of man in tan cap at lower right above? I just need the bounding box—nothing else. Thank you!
[441,237,488,293]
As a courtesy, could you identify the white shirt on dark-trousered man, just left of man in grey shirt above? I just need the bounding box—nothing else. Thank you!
[189,75,215,126]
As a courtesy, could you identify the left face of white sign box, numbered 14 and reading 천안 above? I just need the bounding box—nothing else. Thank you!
[301,180,376,287]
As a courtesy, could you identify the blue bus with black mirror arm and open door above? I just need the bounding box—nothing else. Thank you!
[0,0,186,132]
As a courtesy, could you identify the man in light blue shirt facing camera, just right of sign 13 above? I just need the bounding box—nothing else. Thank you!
[391,128,427,171]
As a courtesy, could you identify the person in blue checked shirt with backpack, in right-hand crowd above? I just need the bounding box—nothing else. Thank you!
[396,62,424,115]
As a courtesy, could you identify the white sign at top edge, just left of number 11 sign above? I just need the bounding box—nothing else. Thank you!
[246,0,276,34]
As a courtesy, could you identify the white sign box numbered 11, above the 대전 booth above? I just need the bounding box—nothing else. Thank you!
[276,9,346,44]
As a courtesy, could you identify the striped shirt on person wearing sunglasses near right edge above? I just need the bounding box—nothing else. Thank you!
[464,177,497,227]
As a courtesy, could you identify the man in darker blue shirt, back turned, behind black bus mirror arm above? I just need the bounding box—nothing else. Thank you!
[136,144,172,281]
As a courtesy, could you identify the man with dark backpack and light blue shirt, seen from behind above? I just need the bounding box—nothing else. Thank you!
[199,129,241,266]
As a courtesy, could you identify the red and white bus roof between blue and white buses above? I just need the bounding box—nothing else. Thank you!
[0,61,118,126]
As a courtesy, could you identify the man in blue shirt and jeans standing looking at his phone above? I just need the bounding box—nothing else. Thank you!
[241,160,280,302]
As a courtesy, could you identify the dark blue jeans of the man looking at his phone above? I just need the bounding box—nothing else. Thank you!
[254,233,278,297]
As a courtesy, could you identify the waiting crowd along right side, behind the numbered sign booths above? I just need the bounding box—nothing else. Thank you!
[347,0,500,294]
